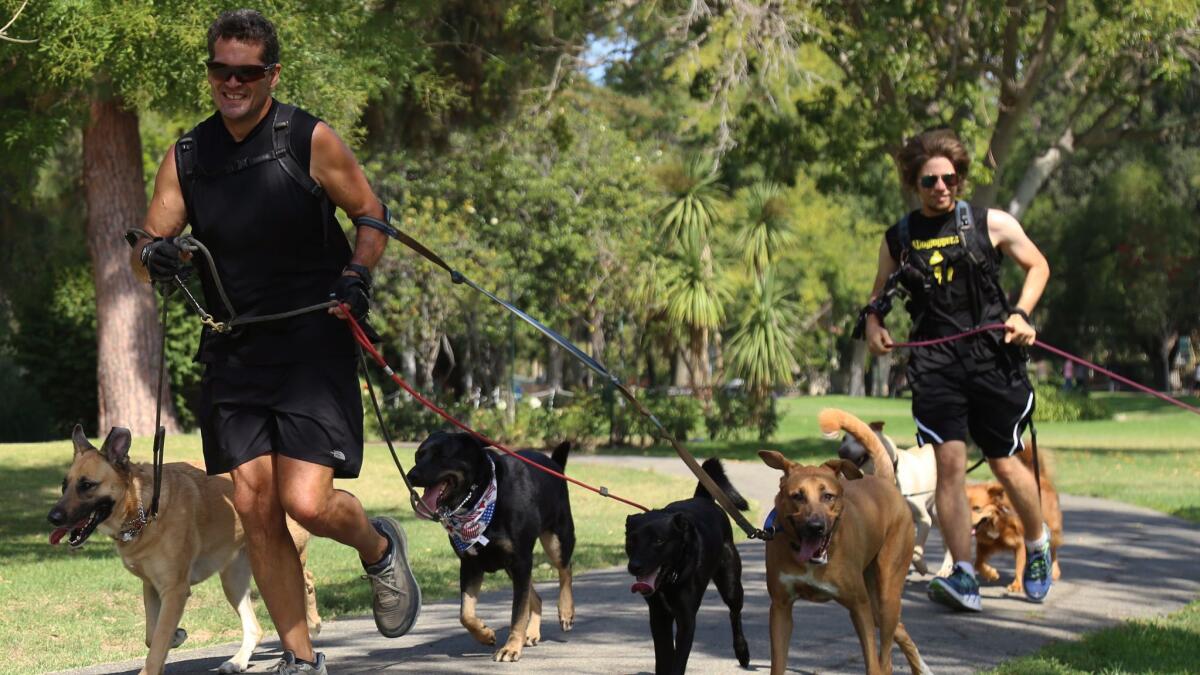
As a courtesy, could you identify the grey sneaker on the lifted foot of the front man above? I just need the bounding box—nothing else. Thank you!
[362,516,421,638]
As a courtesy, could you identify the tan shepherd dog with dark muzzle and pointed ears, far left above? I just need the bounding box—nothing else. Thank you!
[48,425,320,675]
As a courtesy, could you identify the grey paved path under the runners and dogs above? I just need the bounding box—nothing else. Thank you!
[56,458,1200,675]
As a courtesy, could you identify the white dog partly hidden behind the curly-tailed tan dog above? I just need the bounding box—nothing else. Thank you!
[838,413,954,575]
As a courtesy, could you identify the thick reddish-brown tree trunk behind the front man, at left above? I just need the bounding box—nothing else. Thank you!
[83,98,179,436]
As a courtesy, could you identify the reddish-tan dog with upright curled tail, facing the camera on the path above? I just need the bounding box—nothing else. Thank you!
[758,410,929,675]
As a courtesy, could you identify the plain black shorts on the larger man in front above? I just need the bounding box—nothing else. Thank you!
[199,358,362,478]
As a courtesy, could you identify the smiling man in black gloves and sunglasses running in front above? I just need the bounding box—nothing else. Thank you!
[133,10,420,673]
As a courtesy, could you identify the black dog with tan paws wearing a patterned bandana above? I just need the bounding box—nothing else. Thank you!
[408,431,575,661]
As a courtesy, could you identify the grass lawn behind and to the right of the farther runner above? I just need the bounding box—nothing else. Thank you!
[624,393,1200,675]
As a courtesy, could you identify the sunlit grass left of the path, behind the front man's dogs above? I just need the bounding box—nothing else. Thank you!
[0,436,695,673]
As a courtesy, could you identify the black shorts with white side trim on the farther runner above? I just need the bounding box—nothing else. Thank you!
[908,345,1033,459]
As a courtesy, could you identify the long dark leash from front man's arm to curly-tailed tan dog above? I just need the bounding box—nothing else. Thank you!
[362,219,772,540]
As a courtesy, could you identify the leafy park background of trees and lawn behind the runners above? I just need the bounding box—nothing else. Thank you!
[0,0,1200,667]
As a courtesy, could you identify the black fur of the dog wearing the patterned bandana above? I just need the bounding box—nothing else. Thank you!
[408,431,575,638]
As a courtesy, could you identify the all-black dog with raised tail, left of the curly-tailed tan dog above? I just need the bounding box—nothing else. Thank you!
[625,458,750,675]
